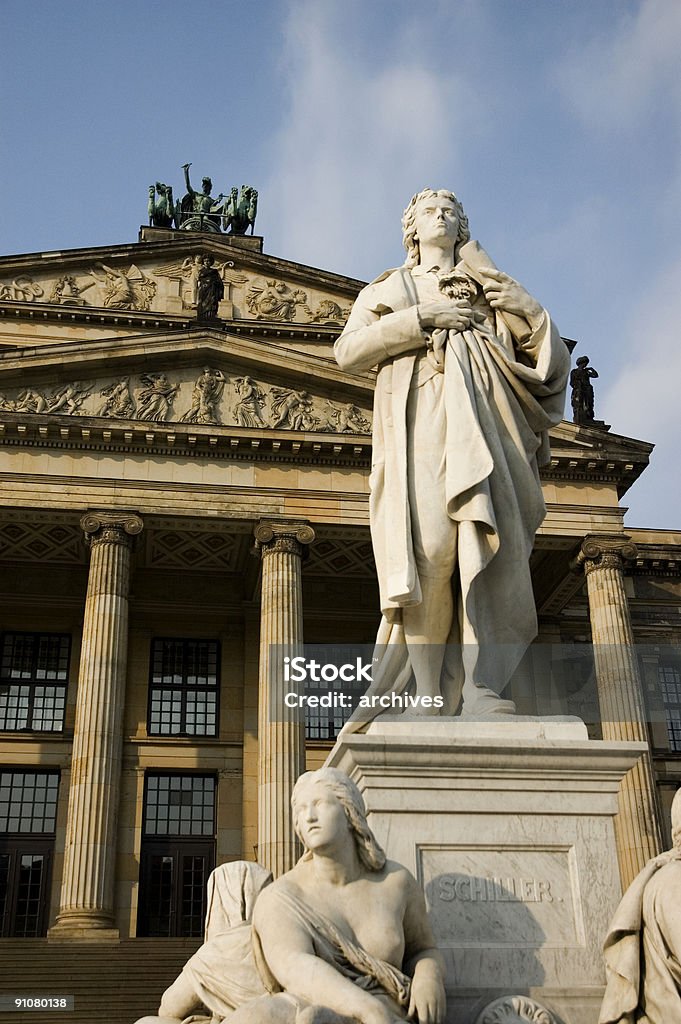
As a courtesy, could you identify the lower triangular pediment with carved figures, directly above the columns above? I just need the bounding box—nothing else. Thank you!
[0,329,373,437]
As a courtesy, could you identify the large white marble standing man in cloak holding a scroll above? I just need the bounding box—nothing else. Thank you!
[335,188,569,728]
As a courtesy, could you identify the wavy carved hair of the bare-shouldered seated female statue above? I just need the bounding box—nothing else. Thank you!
[291,768,385,871]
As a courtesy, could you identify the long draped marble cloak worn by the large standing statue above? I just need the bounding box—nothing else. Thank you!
[335,264,569,721]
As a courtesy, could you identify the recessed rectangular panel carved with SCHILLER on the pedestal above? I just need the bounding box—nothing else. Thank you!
[419,845,585,949]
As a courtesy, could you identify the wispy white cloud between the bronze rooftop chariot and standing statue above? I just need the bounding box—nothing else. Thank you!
[260,0,475,275]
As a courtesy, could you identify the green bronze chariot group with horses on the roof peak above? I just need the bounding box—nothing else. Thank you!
[147,164,258,234]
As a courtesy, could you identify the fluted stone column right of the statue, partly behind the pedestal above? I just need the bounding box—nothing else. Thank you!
[577,534,662,888]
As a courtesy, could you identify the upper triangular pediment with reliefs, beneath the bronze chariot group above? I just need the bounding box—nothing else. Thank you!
[0,228,361,347]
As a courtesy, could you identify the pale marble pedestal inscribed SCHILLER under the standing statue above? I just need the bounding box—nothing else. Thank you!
[327,719,645,1024]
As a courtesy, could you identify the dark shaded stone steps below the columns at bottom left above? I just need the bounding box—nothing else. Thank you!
[0,939,200,1024]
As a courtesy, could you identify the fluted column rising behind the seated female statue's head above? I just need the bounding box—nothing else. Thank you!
[255,520,314,876]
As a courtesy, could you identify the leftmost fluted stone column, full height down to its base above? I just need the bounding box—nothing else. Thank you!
[49,512,142,940]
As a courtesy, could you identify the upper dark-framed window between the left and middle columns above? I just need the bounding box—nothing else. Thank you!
[148,639,219,736]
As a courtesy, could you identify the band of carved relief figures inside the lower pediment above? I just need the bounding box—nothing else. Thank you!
[0,367,372,434]
